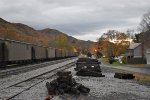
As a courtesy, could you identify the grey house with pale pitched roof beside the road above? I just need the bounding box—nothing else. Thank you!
[126,43,146,64]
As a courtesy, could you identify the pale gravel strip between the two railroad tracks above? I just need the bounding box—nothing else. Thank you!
[0,59,76,90]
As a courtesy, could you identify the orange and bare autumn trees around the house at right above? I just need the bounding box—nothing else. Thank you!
[97,11,150,57]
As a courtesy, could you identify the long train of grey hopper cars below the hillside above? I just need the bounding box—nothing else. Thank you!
[0,38,77,67]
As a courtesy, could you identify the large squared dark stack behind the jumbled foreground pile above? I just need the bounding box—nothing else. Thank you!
[75,58,105,77]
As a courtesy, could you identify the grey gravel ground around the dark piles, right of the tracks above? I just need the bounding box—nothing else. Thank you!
[12,66,150,100]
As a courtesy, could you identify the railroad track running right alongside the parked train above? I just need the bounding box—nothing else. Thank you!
[0,57,75,78]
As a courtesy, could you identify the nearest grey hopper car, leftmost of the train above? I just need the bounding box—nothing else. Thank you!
[0,39,32,64]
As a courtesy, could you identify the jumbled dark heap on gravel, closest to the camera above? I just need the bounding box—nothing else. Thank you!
[46,71,90,95]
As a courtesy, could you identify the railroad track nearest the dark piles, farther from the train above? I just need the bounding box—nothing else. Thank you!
[0,62,75,100]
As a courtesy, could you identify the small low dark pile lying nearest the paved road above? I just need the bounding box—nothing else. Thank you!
[114,73,135,79]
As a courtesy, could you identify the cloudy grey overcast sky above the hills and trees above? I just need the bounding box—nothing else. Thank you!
[0,0,150,41]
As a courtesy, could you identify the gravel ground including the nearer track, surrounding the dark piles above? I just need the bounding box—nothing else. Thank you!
[0,57,150,100]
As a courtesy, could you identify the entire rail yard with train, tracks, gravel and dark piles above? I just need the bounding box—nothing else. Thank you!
[0,32,150,100]
